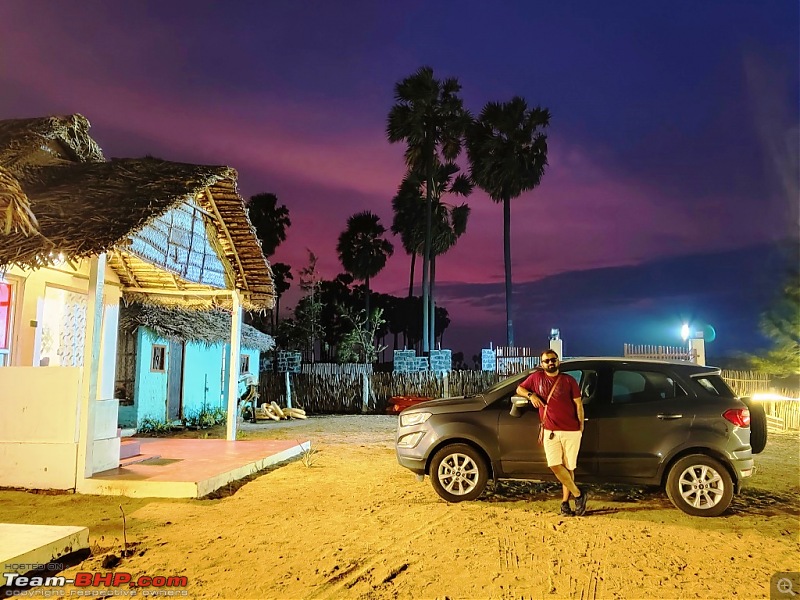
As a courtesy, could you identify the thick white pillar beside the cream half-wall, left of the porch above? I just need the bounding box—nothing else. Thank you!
[75,254,106,480]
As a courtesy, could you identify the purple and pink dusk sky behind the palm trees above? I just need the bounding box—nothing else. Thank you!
[0,0,800,356]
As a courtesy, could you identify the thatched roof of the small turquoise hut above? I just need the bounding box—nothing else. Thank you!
[119,304,275,352]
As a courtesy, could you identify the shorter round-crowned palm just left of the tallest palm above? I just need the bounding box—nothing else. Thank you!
[336,211,394,318]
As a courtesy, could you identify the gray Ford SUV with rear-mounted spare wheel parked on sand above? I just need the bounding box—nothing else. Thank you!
[395,358,766,517]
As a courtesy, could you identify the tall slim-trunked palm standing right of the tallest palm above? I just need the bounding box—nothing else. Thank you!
[467,96,550,346]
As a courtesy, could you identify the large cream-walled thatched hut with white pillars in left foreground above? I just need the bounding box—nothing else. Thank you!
[0,115,274,487]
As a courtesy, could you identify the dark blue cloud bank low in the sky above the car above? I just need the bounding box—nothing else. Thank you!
[437,239,800,357]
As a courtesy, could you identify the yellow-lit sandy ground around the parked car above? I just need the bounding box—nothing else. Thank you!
[0,416,800,600]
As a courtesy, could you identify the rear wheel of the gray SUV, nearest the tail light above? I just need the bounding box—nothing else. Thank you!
[667,454,733,517]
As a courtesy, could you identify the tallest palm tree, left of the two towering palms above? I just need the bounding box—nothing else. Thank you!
[386,67,471,352]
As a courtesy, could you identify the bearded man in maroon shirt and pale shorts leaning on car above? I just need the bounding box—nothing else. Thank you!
[517,350,588,516]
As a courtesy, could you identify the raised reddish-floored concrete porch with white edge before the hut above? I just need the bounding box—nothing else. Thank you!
[78,438,310,498]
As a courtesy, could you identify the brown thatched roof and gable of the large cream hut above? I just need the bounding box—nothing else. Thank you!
[0,115,274,309]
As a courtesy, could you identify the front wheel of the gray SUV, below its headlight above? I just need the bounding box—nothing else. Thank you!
[429,444,489,502]
